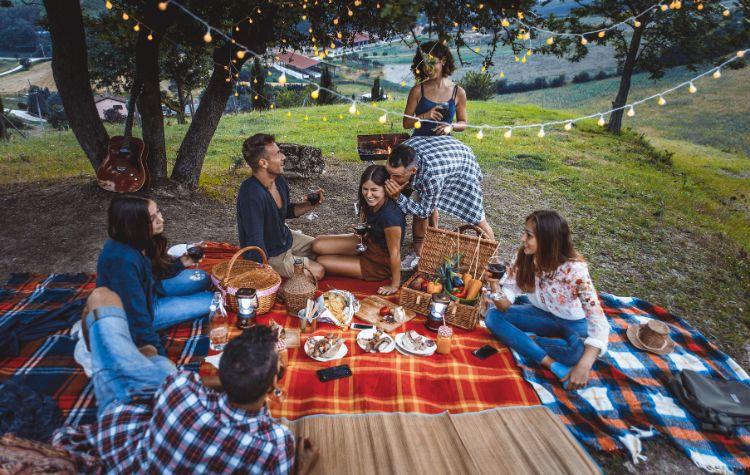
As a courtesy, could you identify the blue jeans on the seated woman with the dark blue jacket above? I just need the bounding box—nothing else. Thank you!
[153,269,214,331]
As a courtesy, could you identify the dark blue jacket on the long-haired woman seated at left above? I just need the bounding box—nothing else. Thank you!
[96,239,166,356]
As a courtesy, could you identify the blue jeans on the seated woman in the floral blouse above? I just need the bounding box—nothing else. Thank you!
[485,304,588,366]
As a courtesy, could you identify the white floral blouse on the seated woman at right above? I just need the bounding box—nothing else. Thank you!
[500,260,609,356]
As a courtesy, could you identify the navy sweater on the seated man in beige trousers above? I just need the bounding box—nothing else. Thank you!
[237,176,294,261]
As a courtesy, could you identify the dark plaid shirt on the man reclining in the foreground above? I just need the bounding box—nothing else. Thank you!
[52,372,294,474]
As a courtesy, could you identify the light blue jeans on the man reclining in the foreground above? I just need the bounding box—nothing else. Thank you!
[85,307,177,416]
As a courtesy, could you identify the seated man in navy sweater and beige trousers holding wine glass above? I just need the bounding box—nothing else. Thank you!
[237,134,325,279]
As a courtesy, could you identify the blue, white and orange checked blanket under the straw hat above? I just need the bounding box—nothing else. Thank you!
[514,294,750,473]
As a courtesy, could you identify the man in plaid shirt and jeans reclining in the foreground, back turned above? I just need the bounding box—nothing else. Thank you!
[53,287,318,474]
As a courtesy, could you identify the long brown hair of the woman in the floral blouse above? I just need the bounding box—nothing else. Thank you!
[513,210,582,292]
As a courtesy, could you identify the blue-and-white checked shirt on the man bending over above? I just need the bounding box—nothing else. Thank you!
[396,136,484,224]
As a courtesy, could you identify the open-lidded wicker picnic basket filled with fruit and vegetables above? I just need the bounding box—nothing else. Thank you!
[399,225,497,330]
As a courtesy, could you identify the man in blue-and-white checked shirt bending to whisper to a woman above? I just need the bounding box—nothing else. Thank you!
[385,139,495,270]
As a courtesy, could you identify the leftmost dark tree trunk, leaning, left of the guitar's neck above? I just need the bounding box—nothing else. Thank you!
[44,0,109,170]
